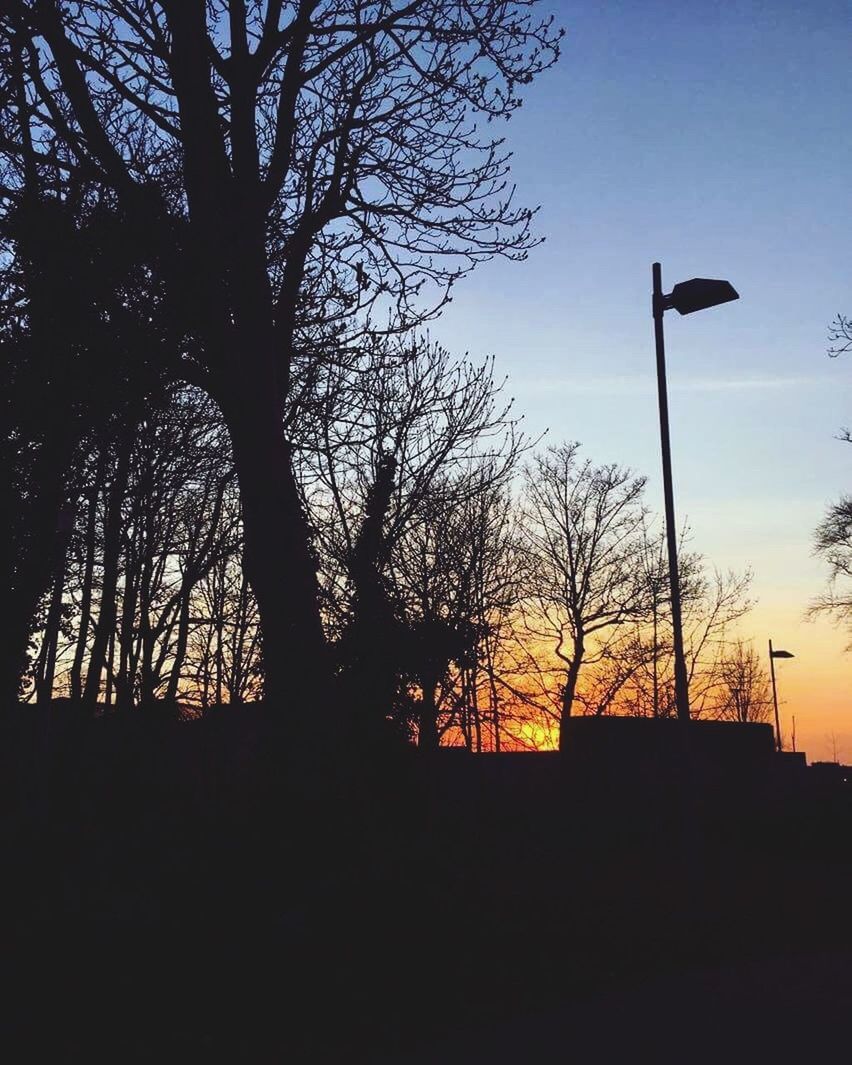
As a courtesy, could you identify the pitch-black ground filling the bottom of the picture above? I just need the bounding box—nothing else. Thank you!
[0,710,852,1063]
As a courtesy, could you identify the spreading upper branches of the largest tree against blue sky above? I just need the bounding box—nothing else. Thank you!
[11,0,560,366]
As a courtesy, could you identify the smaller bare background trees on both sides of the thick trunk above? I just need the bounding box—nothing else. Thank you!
[13,357,769,750]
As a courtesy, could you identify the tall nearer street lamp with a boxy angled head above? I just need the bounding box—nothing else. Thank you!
[651,263,739,722]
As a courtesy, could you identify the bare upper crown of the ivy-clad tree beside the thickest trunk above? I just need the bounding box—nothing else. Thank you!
[298,335,526,617]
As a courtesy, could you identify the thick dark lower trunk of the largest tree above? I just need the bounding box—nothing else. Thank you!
[220,379,330,721]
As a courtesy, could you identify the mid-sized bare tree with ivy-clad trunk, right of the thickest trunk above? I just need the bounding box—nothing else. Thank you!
[299,335,524,741]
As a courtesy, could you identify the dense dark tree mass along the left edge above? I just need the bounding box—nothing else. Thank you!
[0,18,177,695]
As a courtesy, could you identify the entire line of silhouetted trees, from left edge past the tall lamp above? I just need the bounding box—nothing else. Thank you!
[0,0,766,750]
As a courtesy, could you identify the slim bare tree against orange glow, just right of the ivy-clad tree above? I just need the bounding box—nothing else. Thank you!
[389,462,523,750]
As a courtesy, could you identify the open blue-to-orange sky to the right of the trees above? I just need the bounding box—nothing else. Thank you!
[431,0,852,763]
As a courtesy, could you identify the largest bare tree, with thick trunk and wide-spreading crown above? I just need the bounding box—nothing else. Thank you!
[5,0,559,705]
